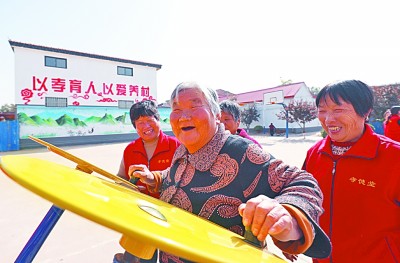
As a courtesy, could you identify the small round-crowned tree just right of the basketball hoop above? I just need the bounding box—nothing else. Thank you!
[276,100,317,138]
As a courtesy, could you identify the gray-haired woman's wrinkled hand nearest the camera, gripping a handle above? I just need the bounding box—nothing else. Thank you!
[239,195,303,242]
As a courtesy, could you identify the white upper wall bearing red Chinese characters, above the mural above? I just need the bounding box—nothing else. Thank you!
[14,47,157,106]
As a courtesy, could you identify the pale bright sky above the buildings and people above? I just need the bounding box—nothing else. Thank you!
[0,0,400,105]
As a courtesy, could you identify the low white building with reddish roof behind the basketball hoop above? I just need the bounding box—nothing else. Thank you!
[217,82,321,133]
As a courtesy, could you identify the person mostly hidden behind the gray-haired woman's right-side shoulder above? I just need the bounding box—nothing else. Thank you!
[219,100,262,148]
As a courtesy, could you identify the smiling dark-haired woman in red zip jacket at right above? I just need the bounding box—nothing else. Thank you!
[303,80,400,263]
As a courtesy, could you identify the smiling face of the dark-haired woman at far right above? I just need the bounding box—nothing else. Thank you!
[318,96,365,142]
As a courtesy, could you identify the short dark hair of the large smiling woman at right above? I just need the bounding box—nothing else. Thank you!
[315,80,374,117]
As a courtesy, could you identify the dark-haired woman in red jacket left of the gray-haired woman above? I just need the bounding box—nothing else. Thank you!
[114,100,180,263]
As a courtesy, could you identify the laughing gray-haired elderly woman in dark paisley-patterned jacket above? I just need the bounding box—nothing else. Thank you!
[129,82,331,263]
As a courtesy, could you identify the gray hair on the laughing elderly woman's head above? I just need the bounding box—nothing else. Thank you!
[171,82,221,116]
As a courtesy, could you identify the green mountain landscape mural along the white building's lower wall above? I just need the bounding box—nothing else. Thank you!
[18,105,171,139]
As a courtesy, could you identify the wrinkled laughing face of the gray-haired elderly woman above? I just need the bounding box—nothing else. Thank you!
[170,88,217,153]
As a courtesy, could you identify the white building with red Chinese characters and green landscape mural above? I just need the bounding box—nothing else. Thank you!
[9,40,170,148]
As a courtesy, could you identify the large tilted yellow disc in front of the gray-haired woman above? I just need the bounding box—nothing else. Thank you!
[0,155,286,263]
